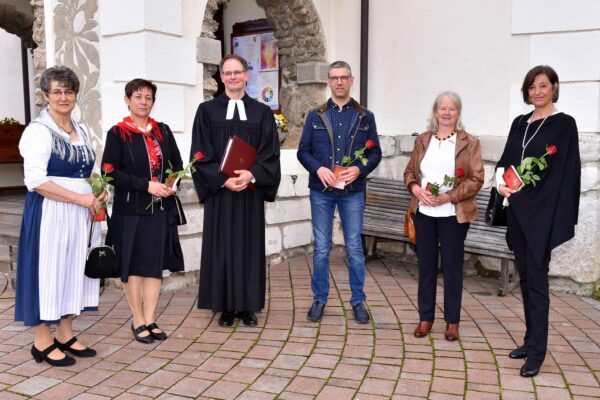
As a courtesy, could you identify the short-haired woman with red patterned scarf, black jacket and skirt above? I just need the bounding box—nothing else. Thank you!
[102,79,183,343]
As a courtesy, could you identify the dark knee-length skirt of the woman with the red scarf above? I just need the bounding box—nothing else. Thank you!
[107,208,184,282]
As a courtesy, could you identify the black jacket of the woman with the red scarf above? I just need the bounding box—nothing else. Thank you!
[102,122,183,215]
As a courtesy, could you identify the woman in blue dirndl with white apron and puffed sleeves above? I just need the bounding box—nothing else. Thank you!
[15,67,107,367]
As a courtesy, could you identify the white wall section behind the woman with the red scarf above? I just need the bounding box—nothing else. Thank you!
[99,0,206,158]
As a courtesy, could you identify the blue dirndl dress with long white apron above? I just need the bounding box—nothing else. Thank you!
[15,128,101,326]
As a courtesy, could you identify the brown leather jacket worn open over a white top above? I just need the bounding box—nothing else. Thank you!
[404,131,484,224]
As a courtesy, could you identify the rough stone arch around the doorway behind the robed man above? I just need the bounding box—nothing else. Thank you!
[201,0,327,148]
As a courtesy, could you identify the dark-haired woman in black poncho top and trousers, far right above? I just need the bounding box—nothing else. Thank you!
[496,65,581,377]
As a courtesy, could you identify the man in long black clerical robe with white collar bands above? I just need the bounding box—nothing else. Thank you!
[191,55,281,326]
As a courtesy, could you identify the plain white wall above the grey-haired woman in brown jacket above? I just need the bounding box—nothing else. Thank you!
[369,0,529,135]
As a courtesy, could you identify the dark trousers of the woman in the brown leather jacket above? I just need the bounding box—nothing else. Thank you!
[414,211,470,324]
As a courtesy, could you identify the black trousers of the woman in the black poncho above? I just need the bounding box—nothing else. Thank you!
[506,206,550,368]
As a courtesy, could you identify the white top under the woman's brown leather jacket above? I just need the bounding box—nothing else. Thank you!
[419,135,456,217]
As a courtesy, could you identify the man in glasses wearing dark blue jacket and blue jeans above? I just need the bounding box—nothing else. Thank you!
[298,61,381,324]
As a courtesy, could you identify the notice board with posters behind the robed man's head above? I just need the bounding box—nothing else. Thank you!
[231,19,281,112]
